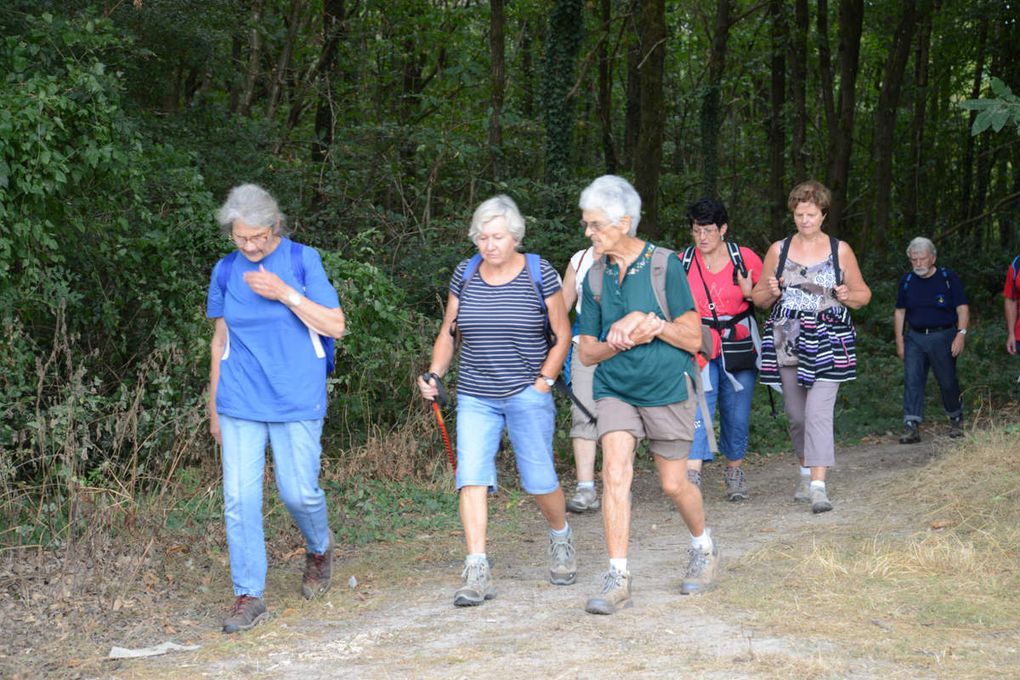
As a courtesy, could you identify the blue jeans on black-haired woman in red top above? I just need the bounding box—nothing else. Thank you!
[687,357,757,461]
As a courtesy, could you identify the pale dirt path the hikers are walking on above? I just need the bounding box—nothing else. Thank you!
[99,436,932,680]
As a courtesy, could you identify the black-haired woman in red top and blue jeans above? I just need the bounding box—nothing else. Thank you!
[681,199,762,501]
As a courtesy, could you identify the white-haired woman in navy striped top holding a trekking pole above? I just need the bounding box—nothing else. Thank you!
[418,196,577,607]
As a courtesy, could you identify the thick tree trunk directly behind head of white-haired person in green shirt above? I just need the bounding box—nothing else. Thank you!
[634,0,666,241]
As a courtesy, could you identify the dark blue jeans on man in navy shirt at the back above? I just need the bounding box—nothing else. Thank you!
[903,328,963,423]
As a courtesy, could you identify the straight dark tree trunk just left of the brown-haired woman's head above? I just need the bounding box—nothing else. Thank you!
[768,0,788,236]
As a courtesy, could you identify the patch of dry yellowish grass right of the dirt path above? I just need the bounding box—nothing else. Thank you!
[722,429,1020,677]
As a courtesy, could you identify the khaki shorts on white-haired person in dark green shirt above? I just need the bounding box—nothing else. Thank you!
[597,378,698,461]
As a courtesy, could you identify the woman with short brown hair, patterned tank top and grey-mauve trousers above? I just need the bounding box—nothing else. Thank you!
[752,180,871,513]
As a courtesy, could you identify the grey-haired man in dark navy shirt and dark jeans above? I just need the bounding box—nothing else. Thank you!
[894,237,970,443]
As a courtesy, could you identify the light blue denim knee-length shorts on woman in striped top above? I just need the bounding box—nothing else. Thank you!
[457,385,560,495]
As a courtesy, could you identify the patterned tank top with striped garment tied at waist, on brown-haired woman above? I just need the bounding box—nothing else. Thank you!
[761,256,857,387]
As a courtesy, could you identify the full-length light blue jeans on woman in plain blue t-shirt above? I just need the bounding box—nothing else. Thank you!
[219,414,329,597]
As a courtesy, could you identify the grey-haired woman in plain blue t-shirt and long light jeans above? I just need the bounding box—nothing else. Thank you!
[207,185,345,633]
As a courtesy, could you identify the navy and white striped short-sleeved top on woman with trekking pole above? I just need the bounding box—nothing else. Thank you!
[450,254,561,399]
